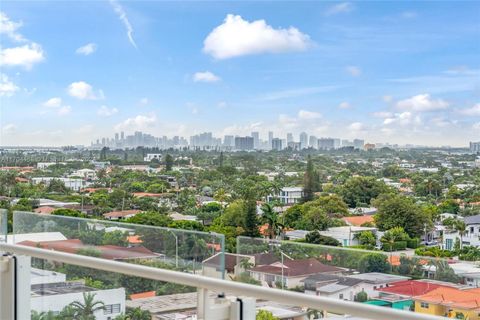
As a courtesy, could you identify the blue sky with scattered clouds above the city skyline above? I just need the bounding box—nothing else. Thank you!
[0,1,480,146]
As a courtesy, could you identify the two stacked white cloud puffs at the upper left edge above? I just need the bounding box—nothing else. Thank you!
[0,12,45,70]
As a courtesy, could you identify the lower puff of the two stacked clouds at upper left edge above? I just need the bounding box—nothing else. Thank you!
[0,42,45,70]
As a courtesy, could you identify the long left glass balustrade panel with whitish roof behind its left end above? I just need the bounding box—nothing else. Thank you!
[13,211,224,278]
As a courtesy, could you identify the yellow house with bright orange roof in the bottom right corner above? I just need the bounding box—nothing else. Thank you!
[413,287,480,320]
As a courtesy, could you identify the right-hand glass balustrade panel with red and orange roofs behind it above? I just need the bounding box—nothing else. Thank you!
[234,237,480,317]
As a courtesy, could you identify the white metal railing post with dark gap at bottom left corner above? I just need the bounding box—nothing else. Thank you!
[0,255,31,320]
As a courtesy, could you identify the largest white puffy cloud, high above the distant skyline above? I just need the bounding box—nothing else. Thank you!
[203,14,311,59]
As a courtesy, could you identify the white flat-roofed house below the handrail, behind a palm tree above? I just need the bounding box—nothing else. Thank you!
[30,281,125,320]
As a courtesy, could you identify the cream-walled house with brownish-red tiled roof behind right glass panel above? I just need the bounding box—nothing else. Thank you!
[248,258,344,289]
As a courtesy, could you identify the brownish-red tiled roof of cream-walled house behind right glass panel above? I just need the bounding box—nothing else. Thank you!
[250,258,342,277]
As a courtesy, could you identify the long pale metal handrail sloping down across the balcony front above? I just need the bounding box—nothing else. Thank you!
[0,243,445,320]
